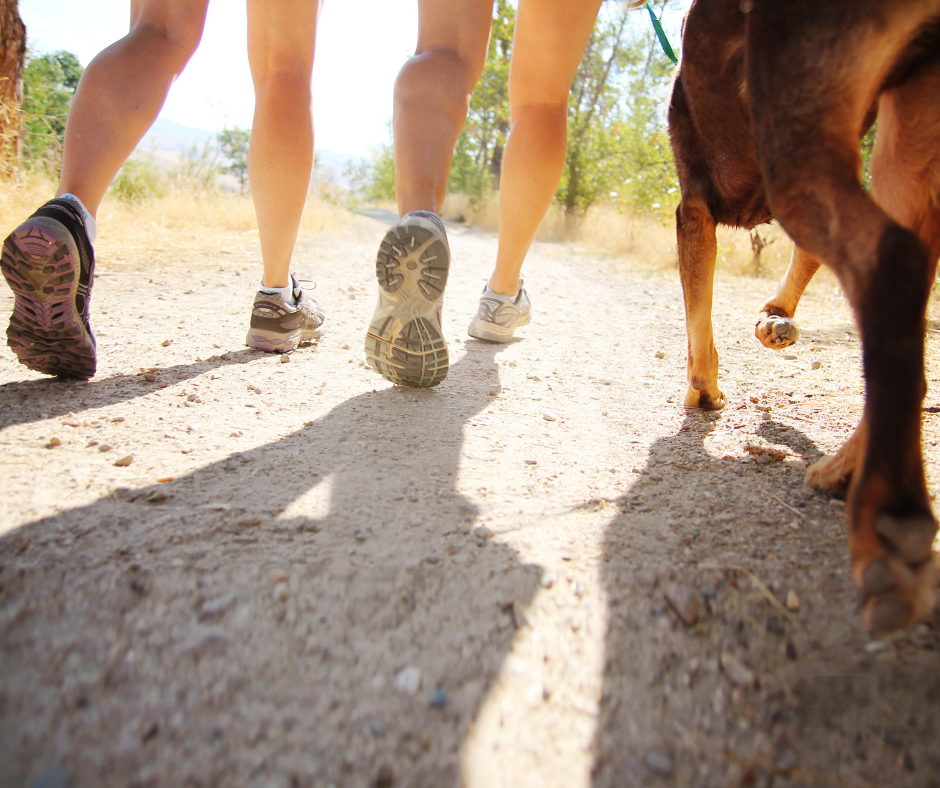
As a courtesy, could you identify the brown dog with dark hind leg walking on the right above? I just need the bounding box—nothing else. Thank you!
[669,0,940,635]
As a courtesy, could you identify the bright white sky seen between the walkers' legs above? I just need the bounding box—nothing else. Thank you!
[20,0,690,156]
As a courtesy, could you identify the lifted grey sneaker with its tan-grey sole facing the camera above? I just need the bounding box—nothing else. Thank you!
[366,211,450,387]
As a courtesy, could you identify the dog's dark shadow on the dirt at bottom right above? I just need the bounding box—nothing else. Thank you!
[594,413,940,788]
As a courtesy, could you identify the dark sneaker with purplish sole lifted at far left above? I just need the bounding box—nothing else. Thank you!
[0,200,96,380]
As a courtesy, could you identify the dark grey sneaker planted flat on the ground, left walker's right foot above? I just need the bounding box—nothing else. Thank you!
[245,274,326,353]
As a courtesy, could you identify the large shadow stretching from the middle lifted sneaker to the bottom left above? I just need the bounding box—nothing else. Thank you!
[0,344,539,786]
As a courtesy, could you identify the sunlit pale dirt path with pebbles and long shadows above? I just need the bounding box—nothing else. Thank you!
[0,209,940,788]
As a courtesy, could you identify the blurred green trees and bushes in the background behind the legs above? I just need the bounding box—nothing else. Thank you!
[0,0,873,276]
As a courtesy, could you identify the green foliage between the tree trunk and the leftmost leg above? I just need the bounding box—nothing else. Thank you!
[22,52,83,176]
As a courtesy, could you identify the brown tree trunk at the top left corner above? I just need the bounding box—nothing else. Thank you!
[0,0,26,177]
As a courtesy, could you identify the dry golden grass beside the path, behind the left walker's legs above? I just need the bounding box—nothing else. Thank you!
[0,177,350,274]
